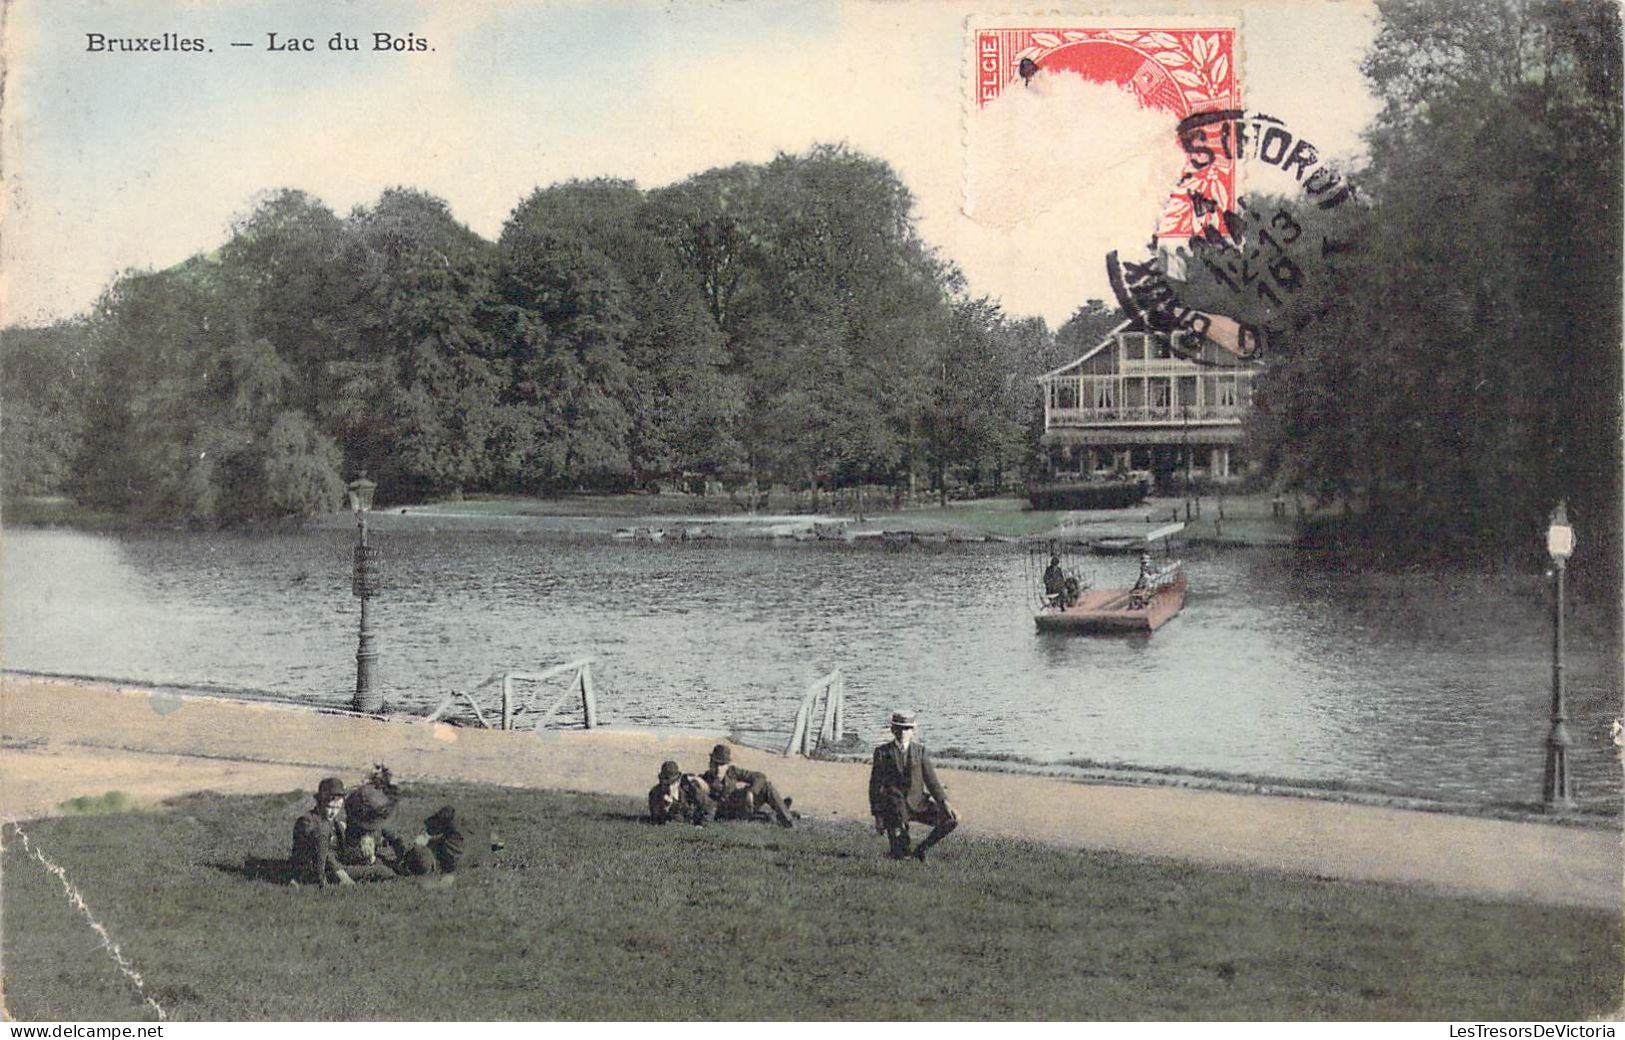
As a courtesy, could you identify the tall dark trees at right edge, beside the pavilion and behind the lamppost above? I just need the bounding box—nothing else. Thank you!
[1228,0,1622,587]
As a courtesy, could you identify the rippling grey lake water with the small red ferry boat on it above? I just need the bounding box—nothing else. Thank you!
[0,518,1620,803]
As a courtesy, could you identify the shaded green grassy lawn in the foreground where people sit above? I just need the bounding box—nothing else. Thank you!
[3,787,1620,1021]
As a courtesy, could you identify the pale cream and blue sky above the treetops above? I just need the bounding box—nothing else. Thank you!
[0,0,1376,327]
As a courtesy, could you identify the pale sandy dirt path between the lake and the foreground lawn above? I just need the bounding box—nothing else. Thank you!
[0,678,1622,910]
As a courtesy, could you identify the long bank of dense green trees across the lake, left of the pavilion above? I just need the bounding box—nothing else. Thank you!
[3,146,1050,522]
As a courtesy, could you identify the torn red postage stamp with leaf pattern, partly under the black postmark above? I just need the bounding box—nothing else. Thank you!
[972,26,1242,239]
